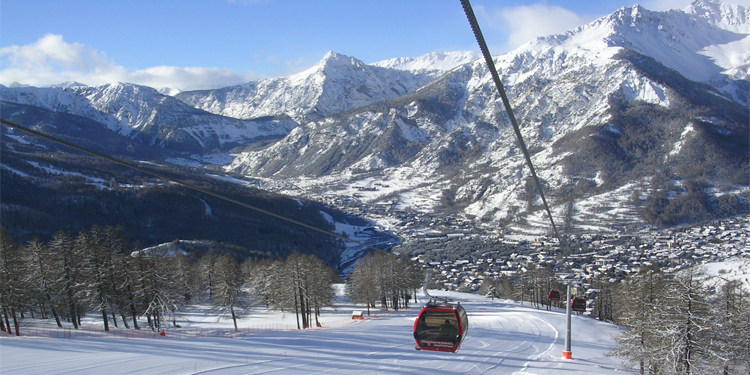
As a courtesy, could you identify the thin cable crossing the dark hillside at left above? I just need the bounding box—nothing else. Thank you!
[0,119,384,251]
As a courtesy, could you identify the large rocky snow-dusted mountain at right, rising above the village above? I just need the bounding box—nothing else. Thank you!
[229,2,748,235]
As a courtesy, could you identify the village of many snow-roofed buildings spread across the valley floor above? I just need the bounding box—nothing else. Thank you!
[402,216,750,292]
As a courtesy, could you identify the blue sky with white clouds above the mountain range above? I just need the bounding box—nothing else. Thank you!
[0,0,750,89]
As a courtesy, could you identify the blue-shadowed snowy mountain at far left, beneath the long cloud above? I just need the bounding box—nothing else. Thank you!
[0,83,297,153]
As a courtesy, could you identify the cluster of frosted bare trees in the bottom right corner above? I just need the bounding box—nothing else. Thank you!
[612,268,750,374]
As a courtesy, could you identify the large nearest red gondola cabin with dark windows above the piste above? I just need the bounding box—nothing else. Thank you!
[414,303,469,353]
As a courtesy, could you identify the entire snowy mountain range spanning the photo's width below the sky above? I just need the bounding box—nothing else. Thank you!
[0,1,750,241]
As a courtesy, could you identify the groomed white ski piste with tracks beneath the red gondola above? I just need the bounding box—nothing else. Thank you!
[0,291,623,375]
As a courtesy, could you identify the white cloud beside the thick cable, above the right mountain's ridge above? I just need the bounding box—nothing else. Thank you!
[477,4,594,50]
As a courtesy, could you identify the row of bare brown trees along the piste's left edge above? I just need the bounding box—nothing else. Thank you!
[0,226,338,335]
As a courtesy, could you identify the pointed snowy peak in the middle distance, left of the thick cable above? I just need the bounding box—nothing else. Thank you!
[176,52,432,122]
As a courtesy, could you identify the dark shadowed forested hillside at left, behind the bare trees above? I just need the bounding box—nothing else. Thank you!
[0,151,344,266]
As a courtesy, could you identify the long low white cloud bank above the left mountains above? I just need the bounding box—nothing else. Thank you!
[0,34,261,90]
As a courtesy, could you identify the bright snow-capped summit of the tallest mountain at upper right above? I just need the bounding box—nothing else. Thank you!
[501,0,750,103]
